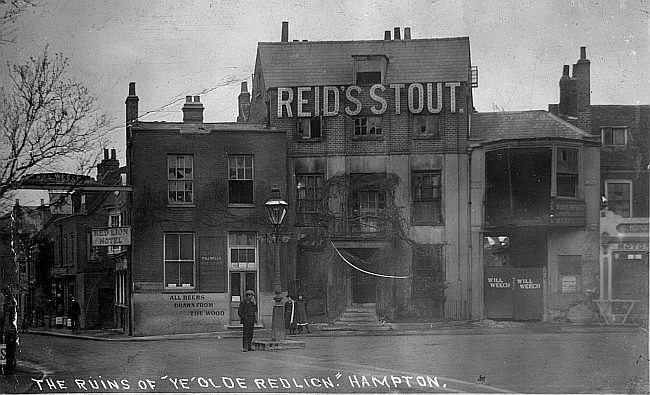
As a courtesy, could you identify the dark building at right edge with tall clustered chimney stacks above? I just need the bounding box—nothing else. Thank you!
[549,47,650,325]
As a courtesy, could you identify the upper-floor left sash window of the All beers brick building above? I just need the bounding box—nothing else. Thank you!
[167,155,194,205]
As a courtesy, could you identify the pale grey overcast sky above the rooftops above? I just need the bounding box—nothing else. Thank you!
[0,0,650,207]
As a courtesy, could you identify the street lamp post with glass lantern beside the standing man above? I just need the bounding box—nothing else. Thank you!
[265,185,289,341]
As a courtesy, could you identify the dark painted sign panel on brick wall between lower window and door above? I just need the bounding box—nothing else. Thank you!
[199,236,227,292]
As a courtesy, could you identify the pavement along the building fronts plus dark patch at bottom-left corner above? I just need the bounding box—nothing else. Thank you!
[0,319,648,393]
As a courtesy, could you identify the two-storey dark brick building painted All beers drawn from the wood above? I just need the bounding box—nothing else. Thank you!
[126,83,286,336]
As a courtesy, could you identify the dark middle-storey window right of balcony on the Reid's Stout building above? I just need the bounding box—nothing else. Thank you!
[411,171,443,225]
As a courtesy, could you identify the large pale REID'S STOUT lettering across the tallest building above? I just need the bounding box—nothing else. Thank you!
[277,82,460,118]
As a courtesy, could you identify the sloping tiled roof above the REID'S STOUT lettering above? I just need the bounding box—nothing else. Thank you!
[257,37,471,89]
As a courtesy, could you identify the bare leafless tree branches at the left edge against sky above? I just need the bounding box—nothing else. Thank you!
[0,49,107,204]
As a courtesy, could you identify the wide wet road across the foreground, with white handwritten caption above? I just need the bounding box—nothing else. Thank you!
[6,331,648,393]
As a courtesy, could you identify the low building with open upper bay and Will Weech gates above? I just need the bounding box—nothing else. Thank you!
[470,111,600,322]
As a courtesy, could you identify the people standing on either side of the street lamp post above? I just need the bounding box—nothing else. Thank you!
[237,290,311,352]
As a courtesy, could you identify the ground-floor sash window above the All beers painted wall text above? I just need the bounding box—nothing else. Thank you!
[164,233,195,290]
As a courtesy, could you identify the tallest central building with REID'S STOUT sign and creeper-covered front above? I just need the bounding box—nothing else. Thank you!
[240,22,478,320]
